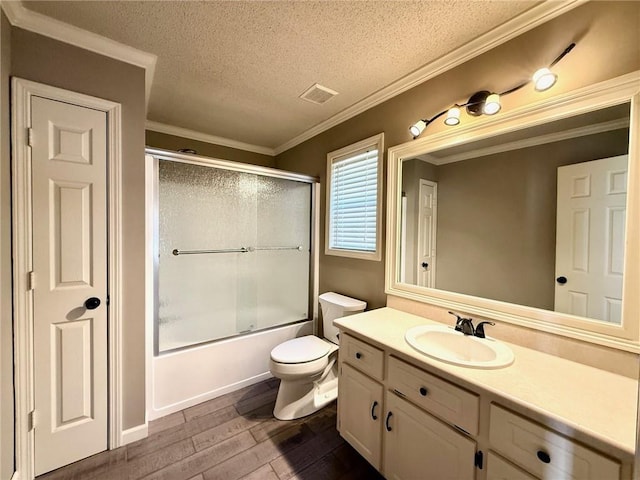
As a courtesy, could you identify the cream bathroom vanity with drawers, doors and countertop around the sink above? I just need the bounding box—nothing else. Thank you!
[336,308,637,480]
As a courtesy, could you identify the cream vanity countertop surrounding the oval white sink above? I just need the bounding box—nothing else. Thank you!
[334,307,638,455]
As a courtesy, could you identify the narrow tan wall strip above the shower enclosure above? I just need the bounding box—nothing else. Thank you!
[145,130,276,168]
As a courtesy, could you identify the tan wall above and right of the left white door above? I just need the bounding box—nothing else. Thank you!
[11,27,145,429]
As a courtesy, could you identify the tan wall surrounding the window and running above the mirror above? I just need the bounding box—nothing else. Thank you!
[276,2,640,314]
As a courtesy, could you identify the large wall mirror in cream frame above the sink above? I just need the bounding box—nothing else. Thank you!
[387,73,640,351]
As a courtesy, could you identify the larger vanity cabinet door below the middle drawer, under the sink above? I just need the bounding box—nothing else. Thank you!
[384,393,476,480]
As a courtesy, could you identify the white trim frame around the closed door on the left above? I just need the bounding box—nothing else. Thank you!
[11,77,122,479]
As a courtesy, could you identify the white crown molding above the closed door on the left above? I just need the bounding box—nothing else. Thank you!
[0,0,158,108]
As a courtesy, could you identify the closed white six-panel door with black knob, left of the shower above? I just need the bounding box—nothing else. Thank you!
[31,97,107,475]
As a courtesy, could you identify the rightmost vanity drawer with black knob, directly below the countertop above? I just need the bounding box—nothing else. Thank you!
[489,404,620,480]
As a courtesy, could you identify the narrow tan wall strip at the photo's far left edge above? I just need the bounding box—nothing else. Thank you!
[0,11,14,480]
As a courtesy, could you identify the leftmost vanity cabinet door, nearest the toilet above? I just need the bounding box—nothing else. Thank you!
[338,364,383,470]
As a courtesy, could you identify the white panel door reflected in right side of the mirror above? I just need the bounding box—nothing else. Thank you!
[555,155,628,324]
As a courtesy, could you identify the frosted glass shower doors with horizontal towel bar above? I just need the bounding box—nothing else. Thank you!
[156,160,311,352]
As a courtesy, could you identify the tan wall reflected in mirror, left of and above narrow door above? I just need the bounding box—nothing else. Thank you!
[402,160,438,285]
